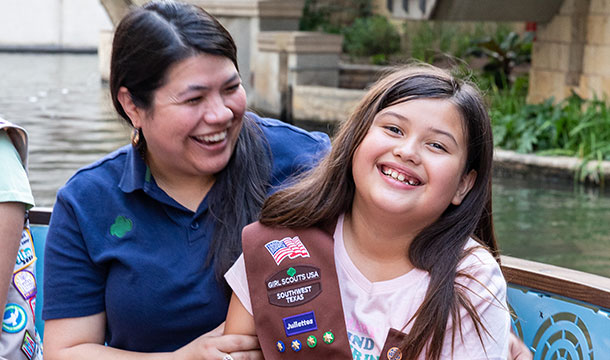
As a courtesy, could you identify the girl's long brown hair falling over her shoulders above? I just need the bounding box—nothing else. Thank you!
[260,65,497,359]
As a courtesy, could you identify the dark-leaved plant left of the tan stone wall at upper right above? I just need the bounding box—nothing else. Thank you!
[468,31,534,88]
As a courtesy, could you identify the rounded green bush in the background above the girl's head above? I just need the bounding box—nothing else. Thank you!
[343,15,400,58]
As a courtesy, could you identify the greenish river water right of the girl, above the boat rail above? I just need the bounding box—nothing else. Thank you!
[493,178,610,277]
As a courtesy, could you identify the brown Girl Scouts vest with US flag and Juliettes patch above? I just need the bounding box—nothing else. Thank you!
[242,222,405,360]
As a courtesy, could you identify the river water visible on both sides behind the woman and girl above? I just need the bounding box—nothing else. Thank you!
[0,54,610,277]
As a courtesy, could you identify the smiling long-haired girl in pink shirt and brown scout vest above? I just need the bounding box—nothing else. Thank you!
[225,66,509,359]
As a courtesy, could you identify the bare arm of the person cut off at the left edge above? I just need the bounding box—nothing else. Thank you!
[0,202,25,326]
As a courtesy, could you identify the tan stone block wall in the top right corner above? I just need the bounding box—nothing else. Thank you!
[528,0,610,103]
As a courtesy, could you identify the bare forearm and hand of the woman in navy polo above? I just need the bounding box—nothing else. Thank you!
[44,312,262,360]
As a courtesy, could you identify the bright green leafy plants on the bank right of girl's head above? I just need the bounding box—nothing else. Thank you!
[489,78,610,181]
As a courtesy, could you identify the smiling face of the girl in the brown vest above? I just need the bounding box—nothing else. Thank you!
[352,99,476,228]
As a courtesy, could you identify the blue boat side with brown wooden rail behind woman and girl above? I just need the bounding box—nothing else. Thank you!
[30,209,610,360]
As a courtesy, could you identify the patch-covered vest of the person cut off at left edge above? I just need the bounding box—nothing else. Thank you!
[0,118,42,360]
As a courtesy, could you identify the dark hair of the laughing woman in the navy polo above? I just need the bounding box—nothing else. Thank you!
[109,1,270,286]
